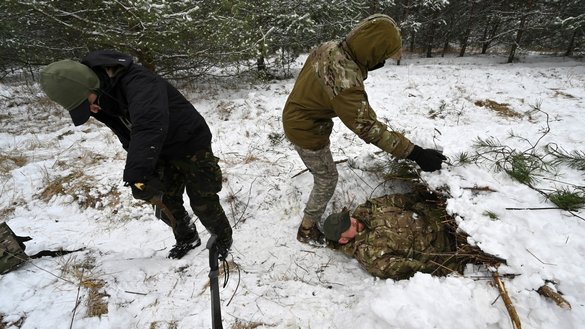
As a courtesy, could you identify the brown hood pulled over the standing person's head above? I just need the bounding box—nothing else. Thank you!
[345,14,402,70]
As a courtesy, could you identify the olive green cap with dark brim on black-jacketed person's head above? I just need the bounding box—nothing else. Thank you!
[41,59,100,126]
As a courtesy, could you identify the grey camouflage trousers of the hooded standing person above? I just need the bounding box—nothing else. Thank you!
[295,144,339,228]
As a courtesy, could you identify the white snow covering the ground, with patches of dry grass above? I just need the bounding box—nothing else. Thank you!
[0,56,585,329]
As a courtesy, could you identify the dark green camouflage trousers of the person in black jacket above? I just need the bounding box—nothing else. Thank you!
[157,149,232,241]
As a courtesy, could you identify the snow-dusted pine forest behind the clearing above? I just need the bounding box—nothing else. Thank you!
[0,0,585,81]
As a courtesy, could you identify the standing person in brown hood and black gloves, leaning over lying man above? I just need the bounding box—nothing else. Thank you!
[282,14,446,243]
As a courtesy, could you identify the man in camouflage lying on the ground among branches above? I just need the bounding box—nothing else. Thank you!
[323,192,504,280]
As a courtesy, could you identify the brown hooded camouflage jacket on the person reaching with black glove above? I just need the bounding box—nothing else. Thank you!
[283,14,414,158]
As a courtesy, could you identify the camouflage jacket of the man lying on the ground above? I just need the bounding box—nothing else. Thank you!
[337,194,466,280]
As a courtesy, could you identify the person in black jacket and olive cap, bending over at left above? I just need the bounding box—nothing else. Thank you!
[40,50,232,258]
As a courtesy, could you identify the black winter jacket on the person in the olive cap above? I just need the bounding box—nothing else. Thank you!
[81,50,211,183]
